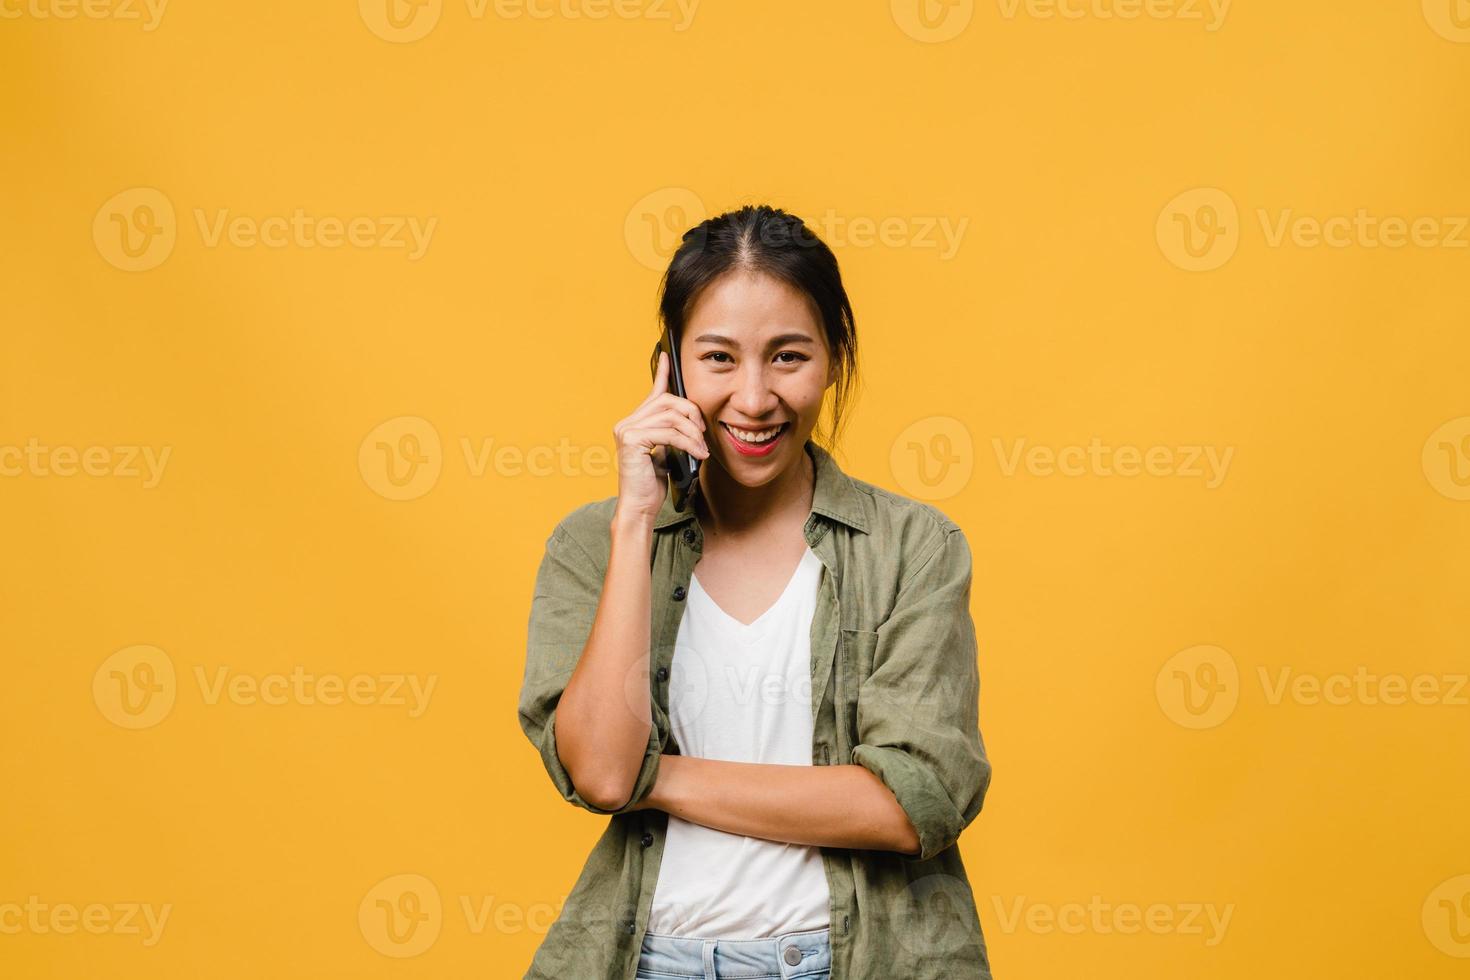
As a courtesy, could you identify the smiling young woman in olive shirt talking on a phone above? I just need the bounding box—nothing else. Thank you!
[519,207,991,980]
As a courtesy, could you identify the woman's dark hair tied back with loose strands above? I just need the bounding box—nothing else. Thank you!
[659,204,857,450]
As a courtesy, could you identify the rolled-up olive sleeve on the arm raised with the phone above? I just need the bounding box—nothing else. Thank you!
[517,522,667,814]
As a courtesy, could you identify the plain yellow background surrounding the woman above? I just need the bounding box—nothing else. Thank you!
[0,0,1470,980]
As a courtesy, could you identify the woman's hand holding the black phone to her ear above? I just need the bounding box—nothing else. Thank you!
[613,351,710,520]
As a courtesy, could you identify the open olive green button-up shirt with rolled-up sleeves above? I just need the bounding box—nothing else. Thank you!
[519,441,991,980]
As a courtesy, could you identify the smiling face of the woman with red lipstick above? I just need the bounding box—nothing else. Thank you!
[679,270,835,486]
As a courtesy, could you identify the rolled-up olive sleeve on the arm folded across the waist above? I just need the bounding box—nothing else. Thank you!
[853,525,991,861]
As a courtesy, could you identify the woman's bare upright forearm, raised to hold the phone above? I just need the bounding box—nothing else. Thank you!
[554,517,653,810]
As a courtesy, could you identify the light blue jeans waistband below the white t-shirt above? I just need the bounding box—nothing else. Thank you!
[638,927,832,980]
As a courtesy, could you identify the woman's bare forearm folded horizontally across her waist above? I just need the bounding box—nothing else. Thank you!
[638,755,919,854]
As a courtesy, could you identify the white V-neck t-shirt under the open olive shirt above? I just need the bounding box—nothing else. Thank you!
[648,548,831,939]
